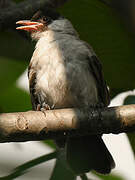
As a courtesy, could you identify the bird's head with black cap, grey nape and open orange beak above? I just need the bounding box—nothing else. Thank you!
[16,9,77,40]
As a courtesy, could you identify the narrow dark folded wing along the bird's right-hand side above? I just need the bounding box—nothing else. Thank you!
[88,55,110,106]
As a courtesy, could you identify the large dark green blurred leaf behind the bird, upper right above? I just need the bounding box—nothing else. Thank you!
[60,0,135,95]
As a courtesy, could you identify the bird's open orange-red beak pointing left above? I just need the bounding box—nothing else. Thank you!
[16,20,44,32]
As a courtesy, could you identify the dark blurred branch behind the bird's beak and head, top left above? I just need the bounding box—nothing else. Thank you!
[0,0,68,30]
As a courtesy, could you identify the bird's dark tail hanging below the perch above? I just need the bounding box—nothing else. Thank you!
[66,135,115,174]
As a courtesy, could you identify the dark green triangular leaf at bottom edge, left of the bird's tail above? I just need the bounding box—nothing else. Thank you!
[50,151,76,180]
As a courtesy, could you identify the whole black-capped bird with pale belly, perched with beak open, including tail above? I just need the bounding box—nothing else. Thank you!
[16,8,115,175]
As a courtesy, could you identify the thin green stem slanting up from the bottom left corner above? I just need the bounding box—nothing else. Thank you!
[0,151,57,180]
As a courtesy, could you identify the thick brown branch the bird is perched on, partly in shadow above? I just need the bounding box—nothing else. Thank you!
[0,105,135,143]
